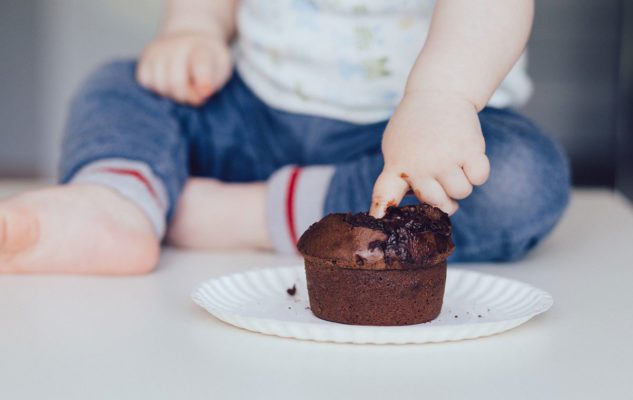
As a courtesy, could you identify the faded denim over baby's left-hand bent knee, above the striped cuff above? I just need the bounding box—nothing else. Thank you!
[60,61,188,219]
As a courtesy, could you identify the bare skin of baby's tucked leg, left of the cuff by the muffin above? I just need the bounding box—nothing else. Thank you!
[167,178,272,250]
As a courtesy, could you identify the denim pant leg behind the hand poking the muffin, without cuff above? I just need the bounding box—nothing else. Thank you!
[324,108,570,262]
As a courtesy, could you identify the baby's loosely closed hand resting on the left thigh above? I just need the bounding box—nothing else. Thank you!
[136,31,232,106]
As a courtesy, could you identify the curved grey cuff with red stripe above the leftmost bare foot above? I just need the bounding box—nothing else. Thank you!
[70,158,169,239]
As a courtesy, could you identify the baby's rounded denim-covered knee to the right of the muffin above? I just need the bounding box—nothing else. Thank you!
[479,120,571,261]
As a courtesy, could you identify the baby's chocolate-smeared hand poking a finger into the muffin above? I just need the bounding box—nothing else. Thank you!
[370,92,490,218]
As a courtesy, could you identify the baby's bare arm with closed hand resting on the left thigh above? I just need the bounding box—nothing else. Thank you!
[137,0,238,105]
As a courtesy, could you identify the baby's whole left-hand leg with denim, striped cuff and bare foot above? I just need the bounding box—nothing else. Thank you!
[0,62,187,274]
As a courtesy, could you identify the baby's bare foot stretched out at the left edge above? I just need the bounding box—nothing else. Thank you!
[0,185,159,274]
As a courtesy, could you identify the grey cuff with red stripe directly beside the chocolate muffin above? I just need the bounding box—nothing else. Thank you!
[266,166,334,254]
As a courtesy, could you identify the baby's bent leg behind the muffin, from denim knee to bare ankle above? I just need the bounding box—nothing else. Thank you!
[170,109,569,261]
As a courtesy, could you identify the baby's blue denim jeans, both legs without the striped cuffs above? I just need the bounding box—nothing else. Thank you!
[61,62,570,261]
